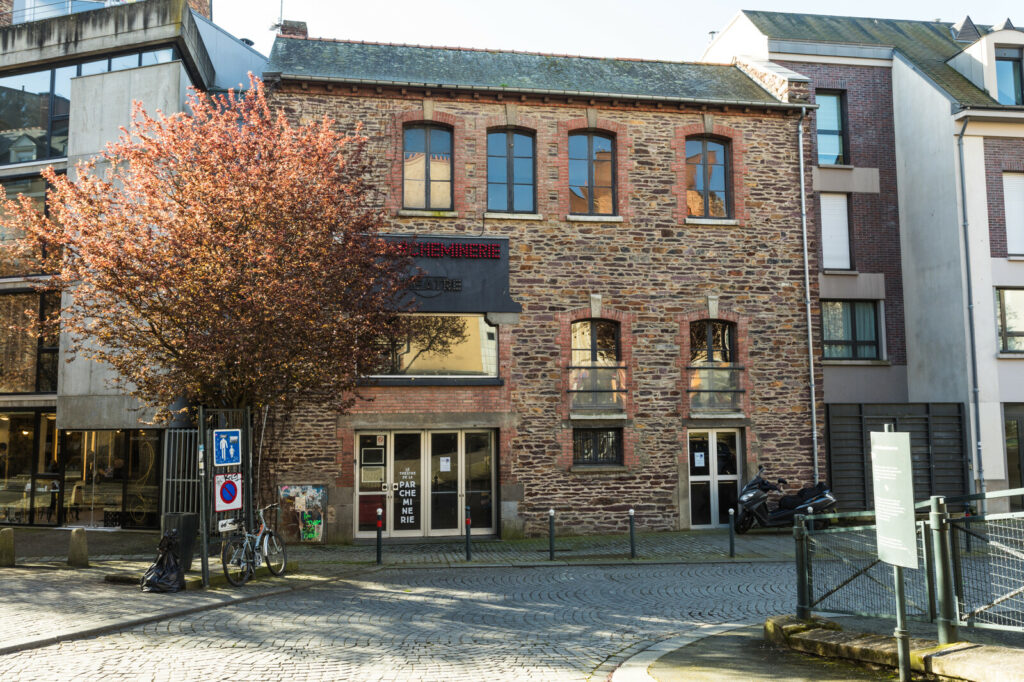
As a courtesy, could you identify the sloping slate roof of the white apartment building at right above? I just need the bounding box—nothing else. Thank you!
[742,9,1001,106]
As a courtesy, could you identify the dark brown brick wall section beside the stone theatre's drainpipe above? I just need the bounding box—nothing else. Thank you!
[777,61,906,365]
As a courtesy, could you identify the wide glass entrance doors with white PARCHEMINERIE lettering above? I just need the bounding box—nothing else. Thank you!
[355,430,495,537]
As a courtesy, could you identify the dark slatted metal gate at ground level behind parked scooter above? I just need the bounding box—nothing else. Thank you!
[827,402,970,511]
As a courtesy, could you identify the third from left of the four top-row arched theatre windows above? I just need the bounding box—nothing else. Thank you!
[569,132,615,215]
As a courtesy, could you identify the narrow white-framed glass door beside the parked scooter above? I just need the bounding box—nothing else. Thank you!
[689,429,741,527]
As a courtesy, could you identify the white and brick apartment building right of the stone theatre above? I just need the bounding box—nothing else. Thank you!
[705,11,1024,509]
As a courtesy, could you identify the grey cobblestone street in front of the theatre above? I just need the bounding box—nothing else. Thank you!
[0,562,795,682]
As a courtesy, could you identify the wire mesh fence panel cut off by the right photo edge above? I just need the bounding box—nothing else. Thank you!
[949,513,1024,630]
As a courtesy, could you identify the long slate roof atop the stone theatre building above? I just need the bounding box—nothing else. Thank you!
[267,36,792,106]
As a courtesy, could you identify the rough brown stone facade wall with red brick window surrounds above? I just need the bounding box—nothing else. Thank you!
[262,75,823,538]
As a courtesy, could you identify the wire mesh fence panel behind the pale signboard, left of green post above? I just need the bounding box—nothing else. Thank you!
[807,513,935,621]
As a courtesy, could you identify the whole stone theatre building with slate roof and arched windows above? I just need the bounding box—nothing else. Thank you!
[265,23,823,540]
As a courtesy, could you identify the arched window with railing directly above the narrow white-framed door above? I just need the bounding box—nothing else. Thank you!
[687,319,742,412]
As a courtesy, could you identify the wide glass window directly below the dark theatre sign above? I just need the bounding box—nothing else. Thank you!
[378,314,498,377]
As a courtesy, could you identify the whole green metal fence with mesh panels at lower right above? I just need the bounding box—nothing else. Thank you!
[794,488,1024,642]
